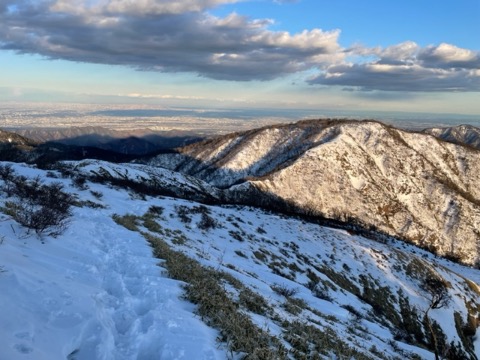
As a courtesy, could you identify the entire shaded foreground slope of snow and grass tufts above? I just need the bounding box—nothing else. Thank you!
[0,161,480,360]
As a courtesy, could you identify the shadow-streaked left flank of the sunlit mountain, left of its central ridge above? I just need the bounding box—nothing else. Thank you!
[148,120,344,188]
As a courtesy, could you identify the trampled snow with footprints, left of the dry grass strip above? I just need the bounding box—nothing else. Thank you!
[0,168,226,360]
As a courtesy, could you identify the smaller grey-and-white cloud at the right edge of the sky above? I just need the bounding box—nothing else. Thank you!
[309,41,480,92]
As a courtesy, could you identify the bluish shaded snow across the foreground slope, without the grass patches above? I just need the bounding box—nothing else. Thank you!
[0,162,480,360]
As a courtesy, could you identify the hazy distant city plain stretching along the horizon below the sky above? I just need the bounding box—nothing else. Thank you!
[0,102,480,135]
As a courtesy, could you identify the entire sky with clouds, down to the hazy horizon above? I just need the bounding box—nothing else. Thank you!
[0,0,480,115]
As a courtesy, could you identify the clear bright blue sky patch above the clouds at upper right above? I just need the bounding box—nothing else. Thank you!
[213,0,480,50]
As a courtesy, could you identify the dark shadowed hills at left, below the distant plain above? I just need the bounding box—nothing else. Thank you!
[0,127,202,164]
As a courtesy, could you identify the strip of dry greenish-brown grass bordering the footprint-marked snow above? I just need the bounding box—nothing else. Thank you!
[143,233,287,360]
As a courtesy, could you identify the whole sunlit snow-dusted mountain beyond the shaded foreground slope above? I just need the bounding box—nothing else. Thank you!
[148,120,480,264]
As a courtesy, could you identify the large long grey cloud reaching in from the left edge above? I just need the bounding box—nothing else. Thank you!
[0,0,344,81]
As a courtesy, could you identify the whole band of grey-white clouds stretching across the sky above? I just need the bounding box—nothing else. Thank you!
[0,0,480,92]
